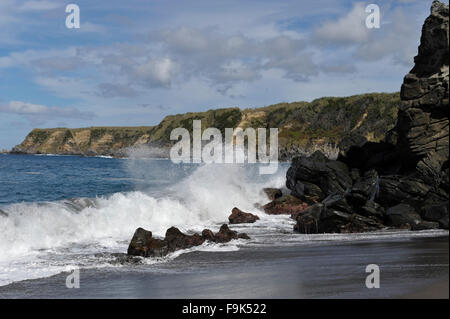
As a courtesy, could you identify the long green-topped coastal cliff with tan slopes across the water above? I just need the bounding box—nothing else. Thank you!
[11,93,400,160]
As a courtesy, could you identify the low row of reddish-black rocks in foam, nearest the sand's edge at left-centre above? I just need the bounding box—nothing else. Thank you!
[127,224,250,257]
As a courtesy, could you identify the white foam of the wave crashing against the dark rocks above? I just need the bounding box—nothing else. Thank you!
[0,165,284,285]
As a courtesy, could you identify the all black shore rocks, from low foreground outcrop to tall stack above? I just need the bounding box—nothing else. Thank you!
[128,1,449,257]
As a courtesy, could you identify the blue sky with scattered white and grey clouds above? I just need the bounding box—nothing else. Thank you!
[0,0,448,149]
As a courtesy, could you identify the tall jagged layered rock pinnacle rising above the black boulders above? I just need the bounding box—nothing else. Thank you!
[396,1,449,168]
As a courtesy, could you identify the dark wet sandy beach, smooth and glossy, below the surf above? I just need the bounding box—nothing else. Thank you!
[0,236,449,299]
